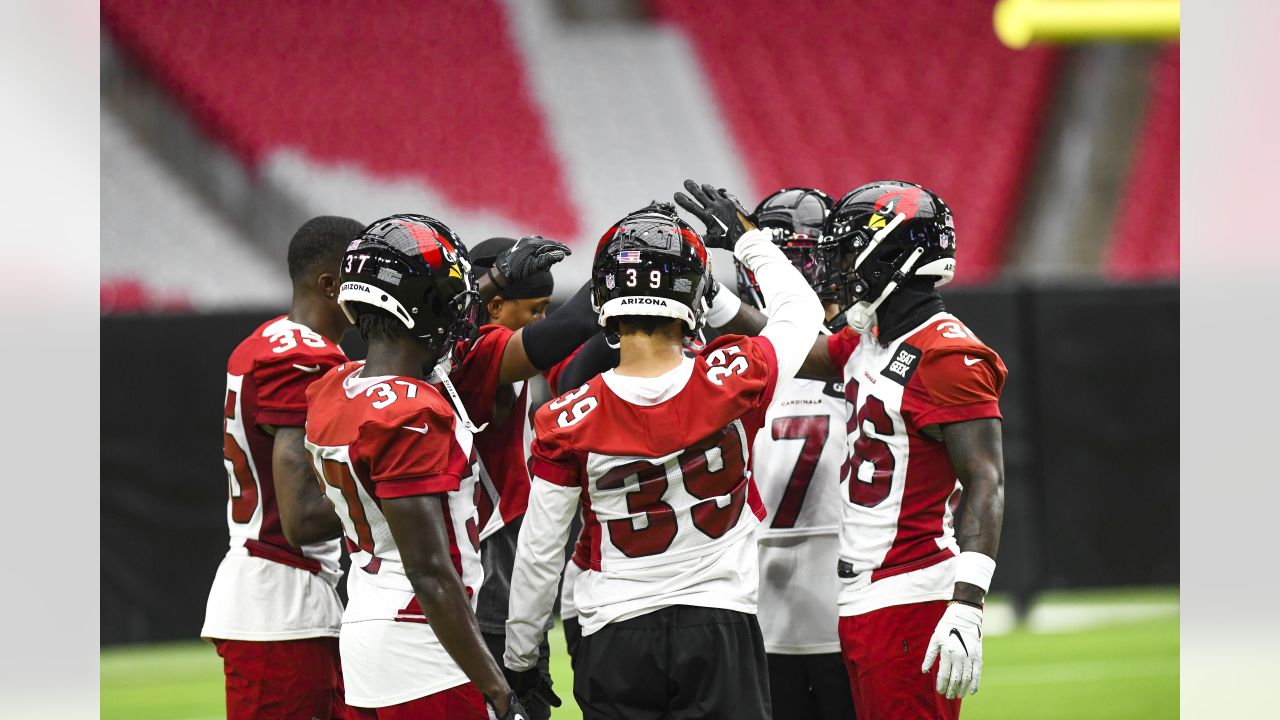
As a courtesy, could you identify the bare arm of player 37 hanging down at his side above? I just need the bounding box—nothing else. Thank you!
[381,495,515,716]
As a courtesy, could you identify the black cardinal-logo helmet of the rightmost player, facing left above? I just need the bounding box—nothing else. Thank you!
[823,181,956,332]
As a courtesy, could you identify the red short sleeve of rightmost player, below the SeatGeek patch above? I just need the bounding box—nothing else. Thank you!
[915,347,1007,427]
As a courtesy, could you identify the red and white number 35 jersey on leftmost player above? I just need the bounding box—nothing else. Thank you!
[202,315,347,641]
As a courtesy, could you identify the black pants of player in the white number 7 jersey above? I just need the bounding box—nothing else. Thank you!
[769,652,854,720]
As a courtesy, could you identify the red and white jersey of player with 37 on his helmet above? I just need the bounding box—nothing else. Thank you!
[306,363,484,707]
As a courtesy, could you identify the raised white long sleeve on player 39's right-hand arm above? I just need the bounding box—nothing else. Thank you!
[733,229,823,384]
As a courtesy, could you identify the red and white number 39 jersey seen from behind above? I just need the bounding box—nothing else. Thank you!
[531,336,778,634]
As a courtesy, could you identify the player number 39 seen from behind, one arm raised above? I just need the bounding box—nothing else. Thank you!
[504,194,822,719]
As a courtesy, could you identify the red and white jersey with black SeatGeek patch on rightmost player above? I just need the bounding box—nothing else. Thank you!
[827,313,1007,615]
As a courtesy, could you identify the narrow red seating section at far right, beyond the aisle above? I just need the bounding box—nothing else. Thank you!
[1105,45,1180,281]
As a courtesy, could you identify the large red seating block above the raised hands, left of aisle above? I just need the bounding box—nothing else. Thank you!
[652,0,1055,283]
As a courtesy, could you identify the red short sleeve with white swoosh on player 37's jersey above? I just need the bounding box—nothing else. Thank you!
[355,407,467,498]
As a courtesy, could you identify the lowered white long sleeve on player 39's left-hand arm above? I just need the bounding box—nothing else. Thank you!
[503,477,579,671]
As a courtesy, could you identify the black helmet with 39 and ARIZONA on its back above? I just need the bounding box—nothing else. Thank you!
[591,201,714,336]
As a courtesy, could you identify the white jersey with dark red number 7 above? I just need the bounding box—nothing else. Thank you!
[751,379,849,655]
